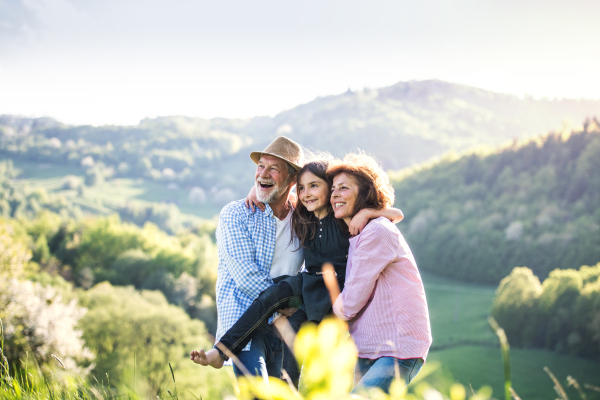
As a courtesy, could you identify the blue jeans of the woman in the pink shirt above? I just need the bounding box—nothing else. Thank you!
[352,357,423,393]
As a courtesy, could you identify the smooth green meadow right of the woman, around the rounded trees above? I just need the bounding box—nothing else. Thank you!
[423,274,600,400]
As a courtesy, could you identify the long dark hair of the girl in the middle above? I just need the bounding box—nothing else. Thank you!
[292,160,345,249]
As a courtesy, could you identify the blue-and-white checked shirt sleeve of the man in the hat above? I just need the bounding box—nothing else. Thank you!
[217,208,273,299]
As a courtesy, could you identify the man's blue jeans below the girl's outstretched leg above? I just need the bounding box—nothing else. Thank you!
[233,325,286,382]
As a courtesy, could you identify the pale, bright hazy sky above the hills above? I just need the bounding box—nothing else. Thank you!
[0,0,600,125]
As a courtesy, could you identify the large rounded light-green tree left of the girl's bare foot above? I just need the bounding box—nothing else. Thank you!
[79,282,210,393]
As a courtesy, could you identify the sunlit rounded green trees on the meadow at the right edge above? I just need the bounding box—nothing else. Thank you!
[492,263,600,361]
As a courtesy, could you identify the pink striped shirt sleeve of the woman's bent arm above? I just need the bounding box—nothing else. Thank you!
[333,220,398,321]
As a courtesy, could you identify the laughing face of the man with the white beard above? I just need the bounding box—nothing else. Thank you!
[255,154,291,204]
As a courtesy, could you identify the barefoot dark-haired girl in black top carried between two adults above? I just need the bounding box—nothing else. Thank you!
[190,161,403,383]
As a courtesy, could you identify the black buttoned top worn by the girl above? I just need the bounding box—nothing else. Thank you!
[285,213,350,321]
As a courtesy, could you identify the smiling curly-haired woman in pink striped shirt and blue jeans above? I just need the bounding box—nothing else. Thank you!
[327,154,432,392]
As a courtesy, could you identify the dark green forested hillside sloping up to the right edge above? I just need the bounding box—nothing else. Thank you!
[392,120,600,283]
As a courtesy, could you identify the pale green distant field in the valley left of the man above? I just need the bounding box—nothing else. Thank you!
[8,160,221,218]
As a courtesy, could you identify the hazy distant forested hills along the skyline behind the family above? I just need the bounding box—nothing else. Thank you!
[0,81,600,202]
